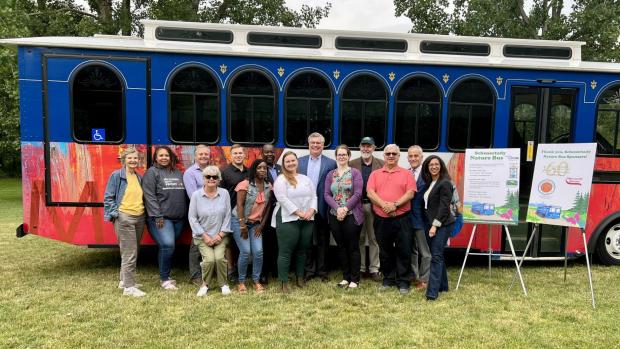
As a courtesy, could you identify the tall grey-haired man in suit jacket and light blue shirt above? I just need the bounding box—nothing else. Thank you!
[298,132,336,281]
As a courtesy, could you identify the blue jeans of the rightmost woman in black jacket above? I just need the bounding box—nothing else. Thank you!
[426,224,453,299]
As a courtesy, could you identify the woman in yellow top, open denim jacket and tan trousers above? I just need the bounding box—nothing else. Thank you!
[103,148,146,297]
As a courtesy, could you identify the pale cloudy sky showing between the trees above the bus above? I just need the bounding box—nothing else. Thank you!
[286,0,573,33]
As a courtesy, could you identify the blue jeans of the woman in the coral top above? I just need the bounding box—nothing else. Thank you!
[230,217,263,283]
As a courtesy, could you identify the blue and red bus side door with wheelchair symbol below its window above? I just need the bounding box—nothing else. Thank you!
[43,53,149,207]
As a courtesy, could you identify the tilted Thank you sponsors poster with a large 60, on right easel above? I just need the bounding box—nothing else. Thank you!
[527,143,596,228]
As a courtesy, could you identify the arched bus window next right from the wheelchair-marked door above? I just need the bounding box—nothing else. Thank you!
[169,67,220,143]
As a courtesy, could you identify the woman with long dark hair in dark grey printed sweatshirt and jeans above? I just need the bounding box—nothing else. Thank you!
[142,146,187,290]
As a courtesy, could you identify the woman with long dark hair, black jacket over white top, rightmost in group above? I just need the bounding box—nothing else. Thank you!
[422,155,454,300]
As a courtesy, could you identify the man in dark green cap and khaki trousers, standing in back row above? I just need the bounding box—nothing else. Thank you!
[349,137,383,281]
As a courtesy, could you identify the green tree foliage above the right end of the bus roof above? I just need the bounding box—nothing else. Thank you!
[394,0,620,61]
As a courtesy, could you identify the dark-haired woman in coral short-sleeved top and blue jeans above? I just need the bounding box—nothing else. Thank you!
[233,159,271,293]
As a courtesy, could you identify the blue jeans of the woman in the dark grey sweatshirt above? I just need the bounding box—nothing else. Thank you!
[148,217,185,281]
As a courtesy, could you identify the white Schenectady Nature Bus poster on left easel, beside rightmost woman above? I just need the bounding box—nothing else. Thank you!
[463,148,520,224]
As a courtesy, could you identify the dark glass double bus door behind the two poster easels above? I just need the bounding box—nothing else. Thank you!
[503,86,577,257]
